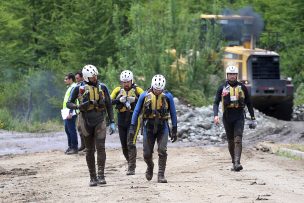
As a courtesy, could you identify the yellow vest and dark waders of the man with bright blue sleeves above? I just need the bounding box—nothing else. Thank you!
[143,93,169,183]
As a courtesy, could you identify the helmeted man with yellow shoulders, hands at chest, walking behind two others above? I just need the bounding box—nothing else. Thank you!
[111,70,143,175]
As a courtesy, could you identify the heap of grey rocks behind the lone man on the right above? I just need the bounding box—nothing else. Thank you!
[174,98,278,145]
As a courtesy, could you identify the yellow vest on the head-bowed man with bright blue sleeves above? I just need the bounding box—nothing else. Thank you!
[143,92,169,120]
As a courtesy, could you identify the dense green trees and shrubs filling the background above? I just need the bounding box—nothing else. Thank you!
[0,0,304,131]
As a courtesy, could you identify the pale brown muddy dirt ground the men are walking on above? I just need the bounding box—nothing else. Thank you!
[0,122,304,202]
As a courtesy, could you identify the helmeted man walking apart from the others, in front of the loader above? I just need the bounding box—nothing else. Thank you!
[213,66,257,171]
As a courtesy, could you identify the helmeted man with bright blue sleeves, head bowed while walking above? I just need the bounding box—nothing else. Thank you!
[129,75,177,183]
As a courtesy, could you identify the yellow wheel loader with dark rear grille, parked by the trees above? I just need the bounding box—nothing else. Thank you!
[201,15,294,120]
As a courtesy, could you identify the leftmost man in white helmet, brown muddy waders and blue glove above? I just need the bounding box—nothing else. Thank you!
[67,65,115,186]
